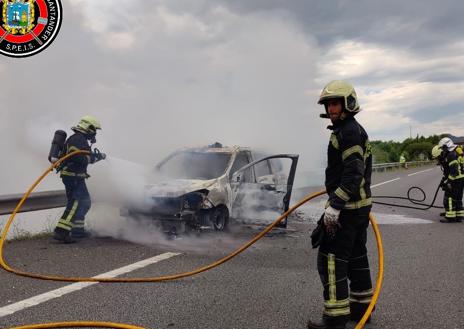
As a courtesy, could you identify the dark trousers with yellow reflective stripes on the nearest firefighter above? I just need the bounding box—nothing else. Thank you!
[317,207,373,317]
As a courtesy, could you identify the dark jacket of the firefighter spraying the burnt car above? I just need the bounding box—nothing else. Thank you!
[61,131,94,178]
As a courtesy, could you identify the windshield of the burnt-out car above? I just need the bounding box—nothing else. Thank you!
[159,152,231,180]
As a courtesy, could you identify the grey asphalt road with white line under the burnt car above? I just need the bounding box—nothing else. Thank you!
[0,167,464,329]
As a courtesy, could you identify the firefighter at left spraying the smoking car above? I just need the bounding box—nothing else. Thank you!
[53,115,106,243]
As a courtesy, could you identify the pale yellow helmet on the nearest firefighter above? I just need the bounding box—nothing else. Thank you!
[318,80,361,113]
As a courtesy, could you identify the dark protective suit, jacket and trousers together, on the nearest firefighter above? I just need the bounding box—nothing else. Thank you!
[318,116,373,323]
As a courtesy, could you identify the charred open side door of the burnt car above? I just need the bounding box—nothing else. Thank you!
[230,154,298,227]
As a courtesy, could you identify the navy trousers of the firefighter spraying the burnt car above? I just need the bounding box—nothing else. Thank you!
[56,176,91,235]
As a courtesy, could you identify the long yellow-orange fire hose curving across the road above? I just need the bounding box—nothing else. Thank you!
[0,151,383,329]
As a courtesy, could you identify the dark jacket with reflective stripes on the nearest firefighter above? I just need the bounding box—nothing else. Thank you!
[325,116,372,210]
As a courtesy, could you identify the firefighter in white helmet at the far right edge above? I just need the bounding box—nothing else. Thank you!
[438,137,464,223]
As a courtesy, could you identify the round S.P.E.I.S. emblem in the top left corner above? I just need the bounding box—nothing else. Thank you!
[0,0,63,57]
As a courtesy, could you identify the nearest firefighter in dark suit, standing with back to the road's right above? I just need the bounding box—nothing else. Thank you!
[308,81,373,329]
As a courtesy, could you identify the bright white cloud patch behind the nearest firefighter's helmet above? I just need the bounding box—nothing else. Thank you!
[317,40,464,140]
